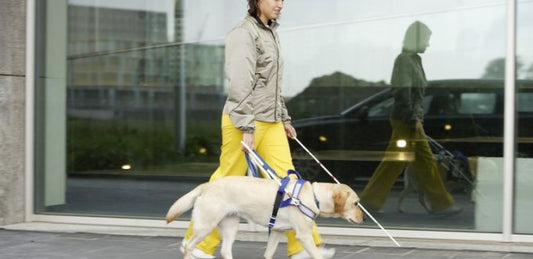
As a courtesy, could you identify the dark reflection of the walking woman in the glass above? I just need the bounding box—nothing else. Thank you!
[361,21,461,216]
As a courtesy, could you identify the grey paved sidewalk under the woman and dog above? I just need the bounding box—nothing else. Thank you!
[0,223,533,259]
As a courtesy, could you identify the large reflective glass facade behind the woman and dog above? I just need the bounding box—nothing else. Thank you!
[34,0,533,234]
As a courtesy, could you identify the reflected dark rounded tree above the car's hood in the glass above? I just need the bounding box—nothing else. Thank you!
[287,72,388,119]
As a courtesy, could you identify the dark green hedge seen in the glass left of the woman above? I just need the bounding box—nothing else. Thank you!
[67,119,220,172]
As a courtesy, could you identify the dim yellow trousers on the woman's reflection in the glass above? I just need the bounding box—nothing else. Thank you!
[360,120,454,211]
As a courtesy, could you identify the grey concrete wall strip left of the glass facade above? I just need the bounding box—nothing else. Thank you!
[0,0,26,225]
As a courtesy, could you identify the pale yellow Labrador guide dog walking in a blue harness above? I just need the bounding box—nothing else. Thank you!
[166,176,363,258]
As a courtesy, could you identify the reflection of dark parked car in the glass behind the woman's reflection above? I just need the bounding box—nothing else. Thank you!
[291,79,533,183]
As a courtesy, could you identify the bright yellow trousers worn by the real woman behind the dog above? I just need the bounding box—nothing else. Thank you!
[185,114,322,256]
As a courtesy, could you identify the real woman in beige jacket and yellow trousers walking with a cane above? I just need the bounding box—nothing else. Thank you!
[183,0,335,258]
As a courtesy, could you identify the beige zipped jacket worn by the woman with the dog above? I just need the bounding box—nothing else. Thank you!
[223,16,291,132]
